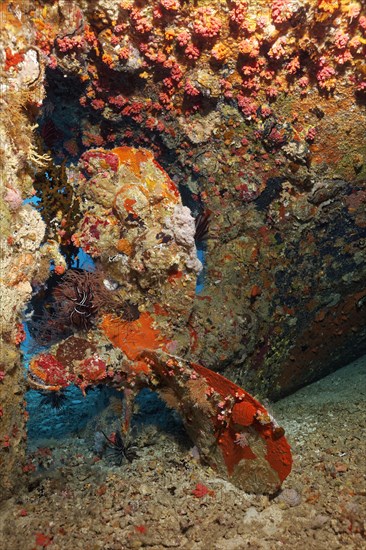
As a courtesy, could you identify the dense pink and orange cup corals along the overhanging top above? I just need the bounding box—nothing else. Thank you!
[29,0,366,124]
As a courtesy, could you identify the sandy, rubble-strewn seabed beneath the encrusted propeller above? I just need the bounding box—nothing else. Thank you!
[0,357,366,550]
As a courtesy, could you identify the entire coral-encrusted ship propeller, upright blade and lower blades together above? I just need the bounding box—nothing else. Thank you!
[28,147,291,493]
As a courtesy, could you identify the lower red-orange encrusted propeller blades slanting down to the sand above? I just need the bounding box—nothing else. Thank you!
[28,320,292,493]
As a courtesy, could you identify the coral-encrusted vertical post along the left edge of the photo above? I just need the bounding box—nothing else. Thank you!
[0,3,45,500]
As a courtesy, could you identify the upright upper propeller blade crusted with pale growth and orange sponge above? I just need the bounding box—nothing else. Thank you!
[72,147,201,348]
